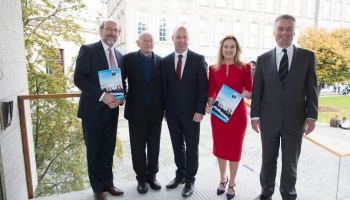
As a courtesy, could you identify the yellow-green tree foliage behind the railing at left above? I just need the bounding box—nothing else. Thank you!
[21,0,87,197]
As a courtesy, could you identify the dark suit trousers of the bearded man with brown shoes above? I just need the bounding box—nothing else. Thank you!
[82,112,118,193]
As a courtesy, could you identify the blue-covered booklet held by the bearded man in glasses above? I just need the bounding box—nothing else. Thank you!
[98,68,124,99]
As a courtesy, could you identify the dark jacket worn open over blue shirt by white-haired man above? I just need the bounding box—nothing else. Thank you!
[123,51,164,122]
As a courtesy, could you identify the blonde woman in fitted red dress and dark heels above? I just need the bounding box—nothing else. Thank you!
[206,36,253,199]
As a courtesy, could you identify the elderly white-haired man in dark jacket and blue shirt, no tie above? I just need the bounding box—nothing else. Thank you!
[123,32,164,193]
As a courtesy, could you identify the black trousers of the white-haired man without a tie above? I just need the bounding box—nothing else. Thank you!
[129,106,162,184]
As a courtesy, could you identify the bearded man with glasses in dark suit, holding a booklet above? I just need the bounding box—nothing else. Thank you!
[74,20,124,200]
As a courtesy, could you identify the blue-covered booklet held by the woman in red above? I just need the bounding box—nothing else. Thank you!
[211,84,242,123]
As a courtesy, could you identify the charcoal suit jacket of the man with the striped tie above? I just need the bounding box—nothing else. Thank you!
[251,47,318,134]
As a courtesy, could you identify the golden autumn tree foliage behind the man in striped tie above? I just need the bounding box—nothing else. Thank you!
[298,28,350,94]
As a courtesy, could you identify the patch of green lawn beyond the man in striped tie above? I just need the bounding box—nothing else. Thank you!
[318,95,350,124]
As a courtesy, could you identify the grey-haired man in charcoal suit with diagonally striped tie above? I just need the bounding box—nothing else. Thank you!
[251,15,318,200]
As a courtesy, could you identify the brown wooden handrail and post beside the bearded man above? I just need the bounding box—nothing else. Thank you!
[17,93,80,199]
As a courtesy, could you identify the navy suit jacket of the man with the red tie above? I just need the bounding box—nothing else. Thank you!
[161,50,208,120]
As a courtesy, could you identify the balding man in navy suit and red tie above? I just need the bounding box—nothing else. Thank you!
[161,26,208,197]
